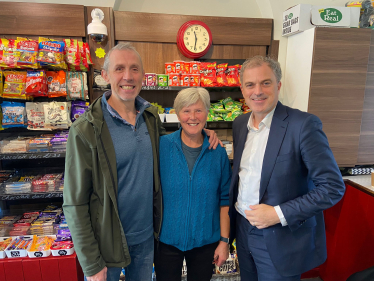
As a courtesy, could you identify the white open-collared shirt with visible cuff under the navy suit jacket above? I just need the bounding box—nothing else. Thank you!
[235,108,287,226]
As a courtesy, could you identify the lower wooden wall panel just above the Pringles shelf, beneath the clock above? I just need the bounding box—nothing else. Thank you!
[122,42,266,73]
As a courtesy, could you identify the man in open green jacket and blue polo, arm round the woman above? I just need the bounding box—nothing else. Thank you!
[63,43,218,281]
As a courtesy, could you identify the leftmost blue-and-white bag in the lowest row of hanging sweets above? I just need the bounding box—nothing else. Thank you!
[1,101,27,128]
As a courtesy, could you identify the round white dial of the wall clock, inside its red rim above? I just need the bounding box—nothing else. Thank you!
[183,24,210,54]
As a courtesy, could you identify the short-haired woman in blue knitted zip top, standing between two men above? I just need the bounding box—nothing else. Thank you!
[155,88,231,281]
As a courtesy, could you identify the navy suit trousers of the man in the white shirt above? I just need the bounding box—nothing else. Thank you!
[236,214,300,281]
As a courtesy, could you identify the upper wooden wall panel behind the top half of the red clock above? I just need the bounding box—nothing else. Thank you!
[114,11,273,45]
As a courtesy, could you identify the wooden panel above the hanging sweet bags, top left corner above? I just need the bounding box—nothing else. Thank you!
[0,2,86,37]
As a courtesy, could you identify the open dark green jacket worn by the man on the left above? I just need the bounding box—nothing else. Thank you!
[63,97,165,276]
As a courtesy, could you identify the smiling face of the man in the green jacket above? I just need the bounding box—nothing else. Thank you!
[102,50,144,102]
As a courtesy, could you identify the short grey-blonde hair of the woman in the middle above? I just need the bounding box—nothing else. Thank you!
[174,87,210,115]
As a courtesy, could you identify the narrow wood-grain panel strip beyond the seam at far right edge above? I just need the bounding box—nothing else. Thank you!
[357,31,374,165]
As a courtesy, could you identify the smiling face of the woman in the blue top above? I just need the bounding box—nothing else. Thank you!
[178,100,208,139]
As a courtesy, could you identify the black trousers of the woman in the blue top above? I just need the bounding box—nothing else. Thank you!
[155,238,218,281]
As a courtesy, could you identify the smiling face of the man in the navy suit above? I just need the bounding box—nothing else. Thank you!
[240,63,281,124]
